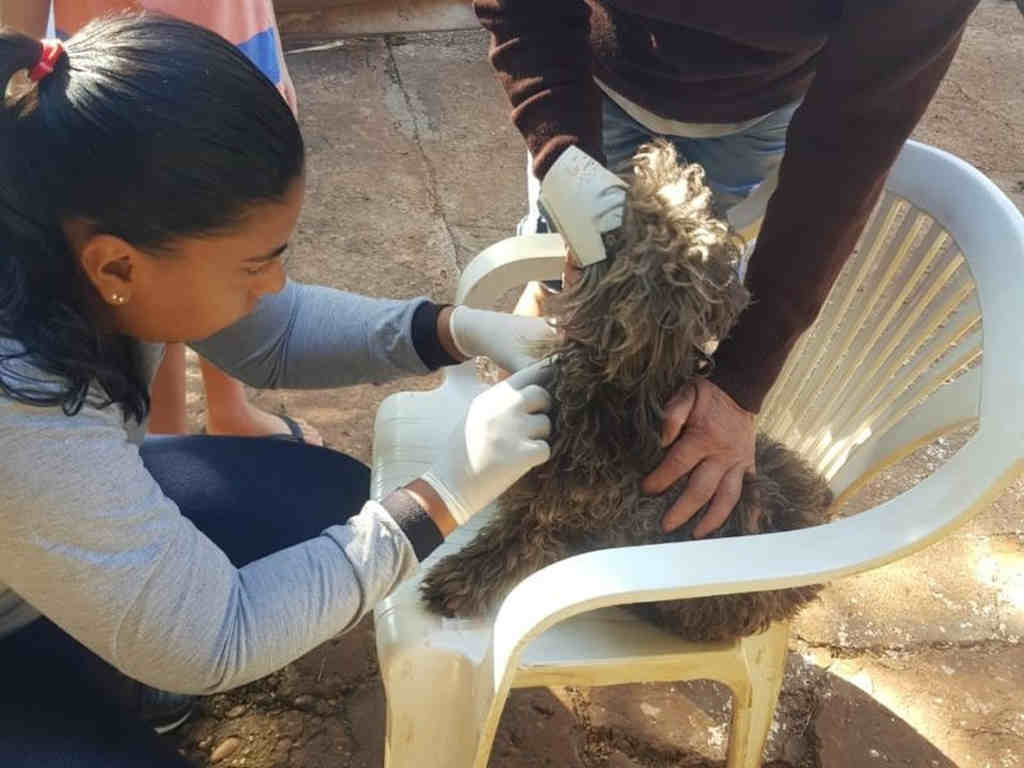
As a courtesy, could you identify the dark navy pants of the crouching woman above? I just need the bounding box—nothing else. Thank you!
[0,436,370,768]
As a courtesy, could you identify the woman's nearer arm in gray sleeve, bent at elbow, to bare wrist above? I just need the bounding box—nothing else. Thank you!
[0,399,452,693]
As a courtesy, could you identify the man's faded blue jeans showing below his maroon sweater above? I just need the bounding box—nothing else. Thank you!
[517,96,800,234]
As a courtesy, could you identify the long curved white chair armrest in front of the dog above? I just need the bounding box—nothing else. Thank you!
[492,432,1024,688]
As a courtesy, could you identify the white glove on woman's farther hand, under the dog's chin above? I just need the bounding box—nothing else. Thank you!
[449,305,556,373]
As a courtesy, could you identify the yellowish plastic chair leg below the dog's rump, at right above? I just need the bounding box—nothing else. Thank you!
[726,623,790,768]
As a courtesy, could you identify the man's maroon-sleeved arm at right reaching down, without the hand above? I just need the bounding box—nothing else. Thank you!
[712,0,977,413]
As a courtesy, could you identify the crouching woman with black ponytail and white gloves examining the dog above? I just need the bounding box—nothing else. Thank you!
[0,14,551,768]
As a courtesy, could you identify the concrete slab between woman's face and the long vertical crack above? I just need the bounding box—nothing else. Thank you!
[288,38,457,296]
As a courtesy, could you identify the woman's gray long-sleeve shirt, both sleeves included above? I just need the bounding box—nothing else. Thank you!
[0,283,443,693]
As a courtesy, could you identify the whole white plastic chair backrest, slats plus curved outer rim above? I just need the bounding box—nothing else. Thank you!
[760,141,1024,501]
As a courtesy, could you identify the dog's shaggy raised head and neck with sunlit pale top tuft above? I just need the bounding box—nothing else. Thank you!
[540,141,749,473]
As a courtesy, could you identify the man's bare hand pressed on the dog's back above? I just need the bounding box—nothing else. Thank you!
[642,379,755,539]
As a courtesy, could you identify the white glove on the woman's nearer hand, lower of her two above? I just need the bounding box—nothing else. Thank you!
[422,360,551,525]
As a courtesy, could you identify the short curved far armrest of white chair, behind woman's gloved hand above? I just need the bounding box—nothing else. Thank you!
[455,234,565,309]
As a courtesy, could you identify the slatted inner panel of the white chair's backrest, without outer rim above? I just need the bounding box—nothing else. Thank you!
[760,184,982,478]
